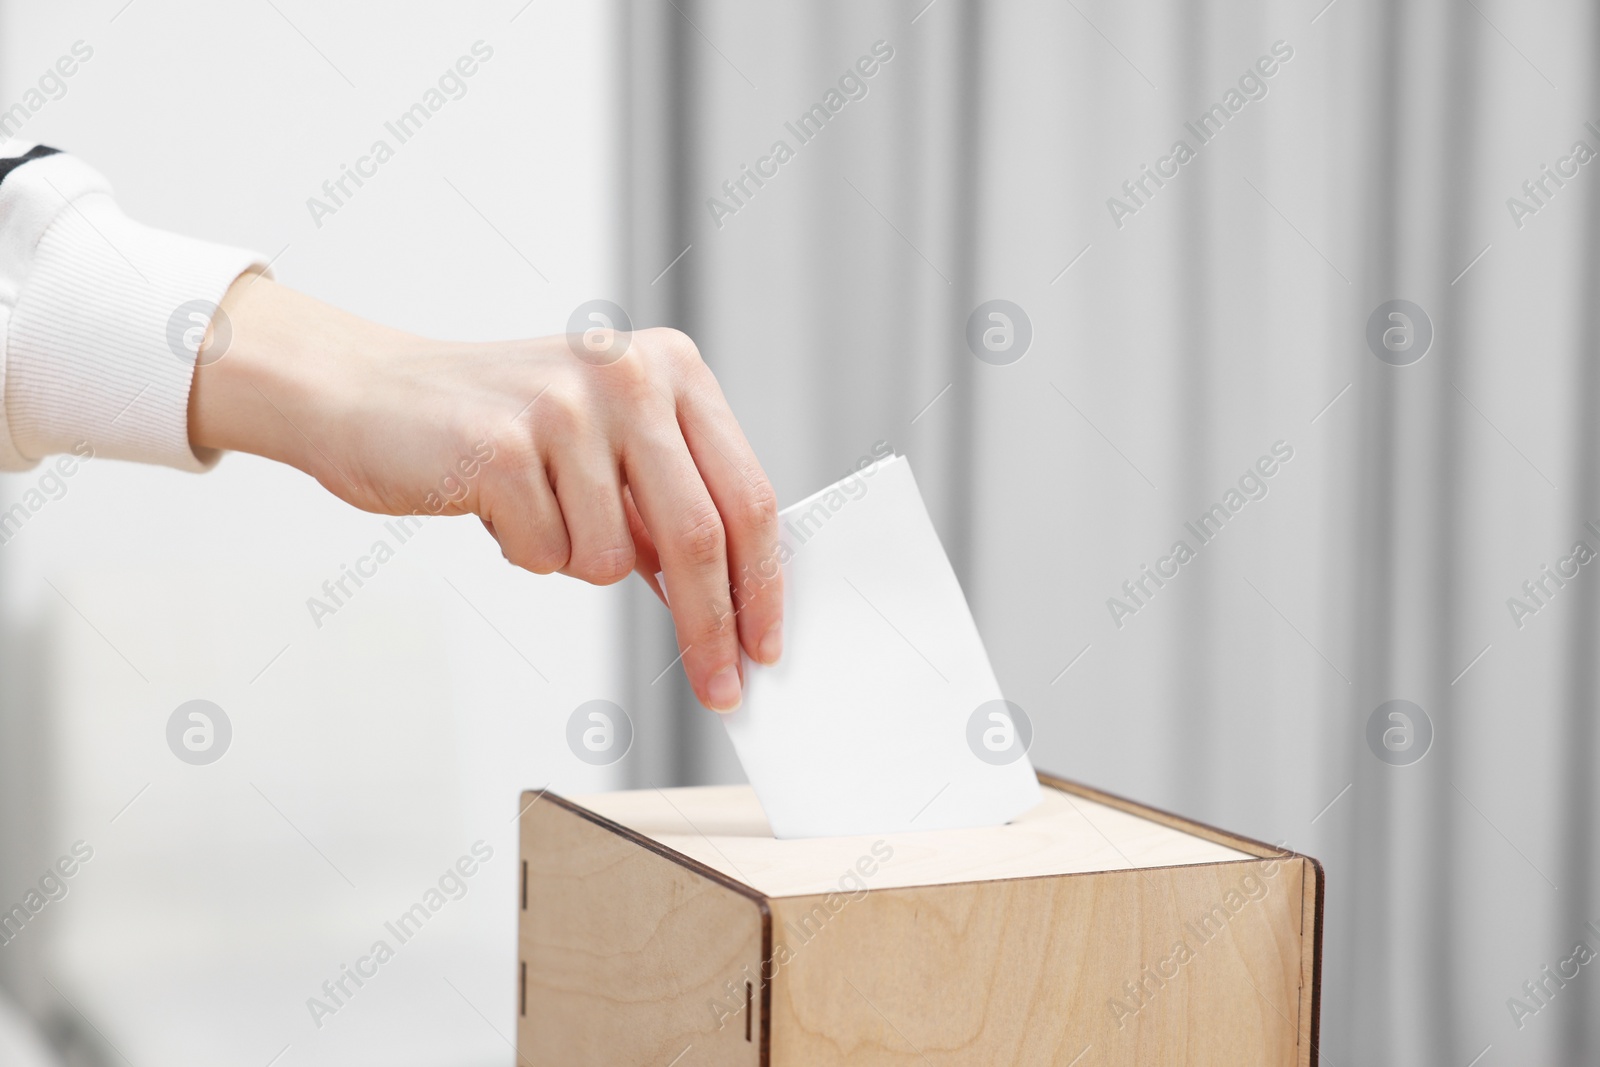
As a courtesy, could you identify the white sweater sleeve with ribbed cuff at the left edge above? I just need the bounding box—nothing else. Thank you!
[0,142,264,470]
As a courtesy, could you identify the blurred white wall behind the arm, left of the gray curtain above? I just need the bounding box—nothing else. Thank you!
[0,0,621,1067]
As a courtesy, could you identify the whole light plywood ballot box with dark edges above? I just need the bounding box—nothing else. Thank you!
[517,774,1323,1067]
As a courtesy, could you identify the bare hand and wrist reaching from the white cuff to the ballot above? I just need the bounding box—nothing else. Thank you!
[189,275,782,712]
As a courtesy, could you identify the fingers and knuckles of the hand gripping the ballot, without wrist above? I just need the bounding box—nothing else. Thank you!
[467,330,782,712]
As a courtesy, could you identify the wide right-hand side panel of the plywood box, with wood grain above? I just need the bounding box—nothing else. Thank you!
[771,857,1307,1067]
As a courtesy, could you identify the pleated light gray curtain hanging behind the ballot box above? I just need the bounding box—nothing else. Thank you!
[622,0,1600,1067]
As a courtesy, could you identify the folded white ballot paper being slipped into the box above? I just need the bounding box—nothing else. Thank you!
[723,456,1040,838]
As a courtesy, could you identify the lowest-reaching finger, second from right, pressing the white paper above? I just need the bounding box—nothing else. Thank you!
[622,419,744,712]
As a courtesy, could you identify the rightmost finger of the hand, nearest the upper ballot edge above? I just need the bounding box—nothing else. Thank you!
[678,367,784,664]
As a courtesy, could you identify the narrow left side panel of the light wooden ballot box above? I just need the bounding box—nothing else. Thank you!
[517,793,766,1067]
